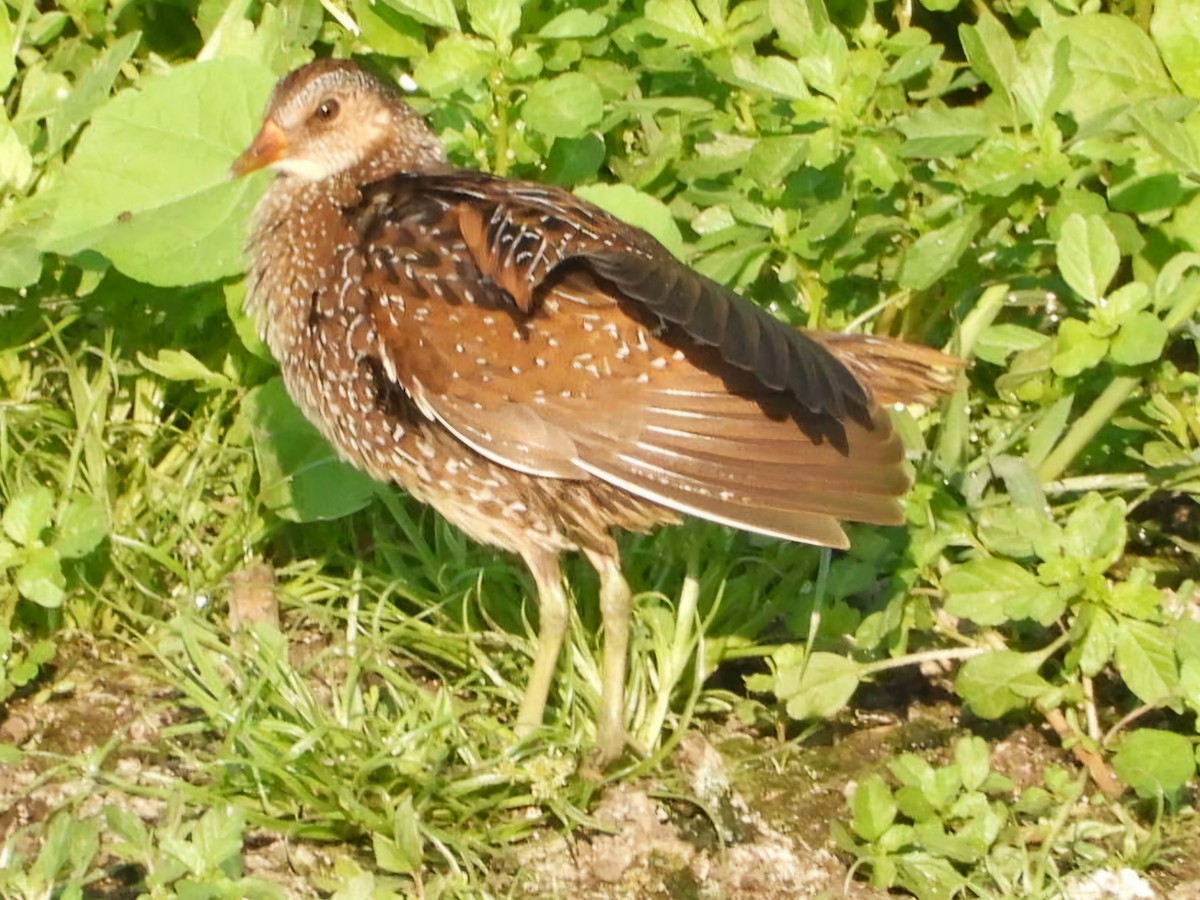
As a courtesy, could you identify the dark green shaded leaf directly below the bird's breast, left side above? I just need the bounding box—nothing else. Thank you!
[242,378,378,522]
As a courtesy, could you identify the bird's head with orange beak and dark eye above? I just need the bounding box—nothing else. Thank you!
[232,60,445,181]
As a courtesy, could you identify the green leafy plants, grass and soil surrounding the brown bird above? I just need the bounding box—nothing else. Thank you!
[0,0,1200,898]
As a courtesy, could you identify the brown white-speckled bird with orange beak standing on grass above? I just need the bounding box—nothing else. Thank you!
[232,59,952,764]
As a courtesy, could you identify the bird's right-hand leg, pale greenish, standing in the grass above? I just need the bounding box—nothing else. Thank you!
[584,544,631,766]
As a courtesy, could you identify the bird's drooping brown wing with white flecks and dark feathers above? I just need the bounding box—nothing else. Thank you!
[349,174,908,546]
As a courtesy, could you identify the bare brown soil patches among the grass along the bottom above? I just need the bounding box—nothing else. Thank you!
[0,640,1200,900]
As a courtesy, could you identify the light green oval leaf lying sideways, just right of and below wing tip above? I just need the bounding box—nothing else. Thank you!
[942,557,1064,625]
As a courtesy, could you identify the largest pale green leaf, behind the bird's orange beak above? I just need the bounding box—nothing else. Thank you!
[41,58,275,286]
